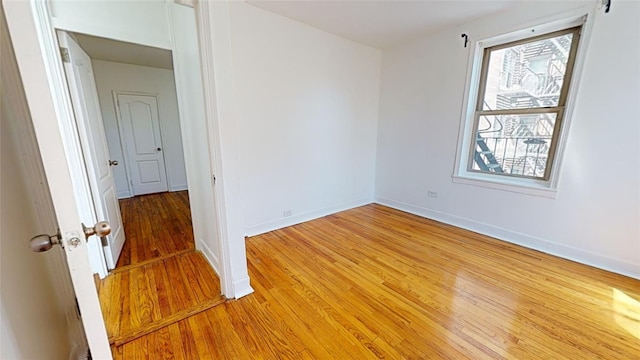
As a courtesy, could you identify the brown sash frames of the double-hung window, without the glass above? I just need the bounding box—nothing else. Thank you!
[467,25,582,181]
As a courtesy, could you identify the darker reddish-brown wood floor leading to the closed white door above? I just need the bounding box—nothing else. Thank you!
[116,191,195,268]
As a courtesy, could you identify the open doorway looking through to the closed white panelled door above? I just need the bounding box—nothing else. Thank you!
[59,32,202,269]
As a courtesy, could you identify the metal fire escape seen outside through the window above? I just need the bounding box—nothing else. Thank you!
[474,36,571,177]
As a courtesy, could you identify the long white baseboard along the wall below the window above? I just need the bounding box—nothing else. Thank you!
[375,196,640,280]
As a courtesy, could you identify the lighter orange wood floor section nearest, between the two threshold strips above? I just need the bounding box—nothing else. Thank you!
[99,251,225,345]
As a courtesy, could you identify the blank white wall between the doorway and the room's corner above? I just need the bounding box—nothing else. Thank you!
[230,3,381,235]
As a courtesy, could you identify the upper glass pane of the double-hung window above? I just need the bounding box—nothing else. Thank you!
[482,33,573,110]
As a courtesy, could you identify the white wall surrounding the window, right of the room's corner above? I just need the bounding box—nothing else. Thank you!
[376,1,640,278]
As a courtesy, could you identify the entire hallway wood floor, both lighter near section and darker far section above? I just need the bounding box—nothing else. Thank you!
[98,191,226,352]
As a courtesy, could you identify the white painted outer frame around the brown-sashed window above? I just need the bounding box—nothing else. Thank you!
[452,9,594,198]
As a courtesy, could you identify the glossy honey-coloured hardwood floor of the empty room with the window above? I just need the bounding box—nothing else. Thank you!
[114,205,640,359]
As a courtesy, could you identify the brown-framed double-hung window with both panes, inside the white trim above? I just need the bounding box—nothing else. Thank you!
[461,26,581,182]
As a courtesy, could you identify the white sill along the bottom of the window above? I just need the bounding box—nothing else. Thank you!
[451,173,558,199]
